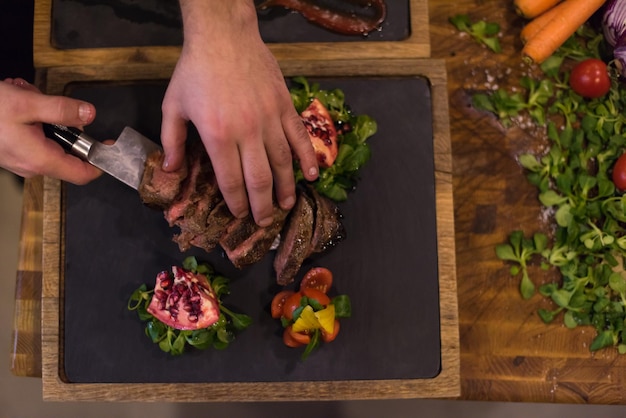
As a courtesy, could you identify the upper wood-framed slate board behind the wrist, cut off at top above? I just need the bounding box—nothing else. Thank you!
[34,0,430,68]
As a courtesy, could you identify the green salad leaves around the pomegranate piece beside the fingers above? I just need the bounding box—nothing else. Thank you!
[290,77,377,202]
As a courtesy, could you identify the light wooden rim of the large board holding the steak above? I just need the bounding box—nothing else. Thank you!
[42,59,461,401]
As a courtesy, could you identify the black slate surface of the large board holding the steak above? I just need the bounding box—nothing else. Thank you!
[62,77,441,383]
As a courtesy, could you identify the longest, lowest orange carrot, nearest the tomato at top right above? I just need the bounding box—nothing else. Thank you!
[522,0,606,64]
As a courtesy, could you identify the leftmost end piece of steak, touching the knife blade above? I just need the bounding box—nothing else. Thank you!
[138,151,188,209]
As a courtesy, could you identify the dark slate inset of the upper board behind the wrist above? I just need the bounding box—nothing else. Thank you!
[51,0,410,49]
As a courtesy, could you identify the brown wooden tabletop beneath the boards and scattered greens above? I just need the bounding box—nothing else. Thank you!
[13,0,626,404]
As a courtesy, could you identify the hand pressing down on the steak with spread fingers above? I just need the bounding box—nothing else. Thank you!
[161,0,318,226]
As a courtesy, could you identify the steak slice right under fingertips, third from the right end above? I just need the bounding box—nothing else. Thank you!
[220,205,289,268]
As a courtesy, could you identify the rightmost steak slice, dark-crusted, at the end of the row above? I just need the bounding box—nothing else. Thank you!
[307,187,346,255]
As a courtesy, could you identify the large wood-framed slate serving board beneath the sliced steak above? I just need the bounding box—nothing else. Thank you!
[36,60,459,401]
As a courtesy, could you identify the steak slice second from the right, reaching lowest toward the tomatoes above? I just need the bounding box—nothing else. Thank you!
[274,192,314,286]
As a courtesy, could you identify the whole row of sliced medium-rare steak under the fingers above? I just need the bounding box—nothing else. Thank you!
[139,142,345,285]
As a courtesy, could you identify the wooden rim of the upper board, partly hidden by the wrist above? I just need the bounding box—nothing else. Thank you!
[33,0,430,68]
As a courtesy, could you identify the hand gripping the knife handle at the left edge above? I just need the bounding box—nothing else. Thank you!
[0,78,102,184]
